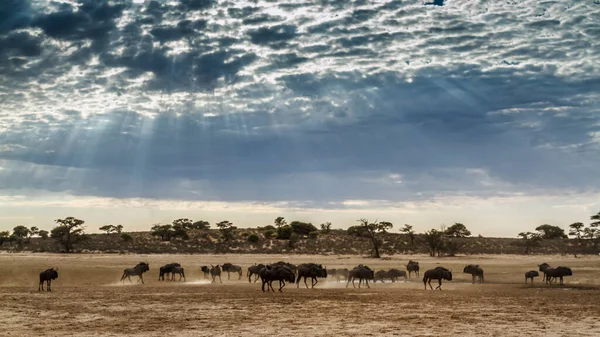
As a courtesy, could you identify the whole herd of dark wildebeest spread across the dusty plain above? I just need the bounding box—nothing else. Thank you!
[38,260,573,291]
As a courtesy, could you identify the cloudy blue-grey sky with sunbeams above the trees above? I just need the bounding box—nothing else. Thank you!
[0,0,600,237]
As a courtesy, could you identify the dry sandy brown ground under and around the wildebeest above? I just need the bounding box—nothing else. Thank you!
[0,253,600,337]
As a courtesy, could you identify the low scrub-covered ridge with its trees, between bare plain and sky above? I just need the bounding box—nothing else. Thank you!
[0,212,600,258]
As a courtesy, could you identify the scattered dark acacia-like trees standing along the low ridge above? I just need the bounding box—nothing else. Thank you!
[0,212,600,258]
